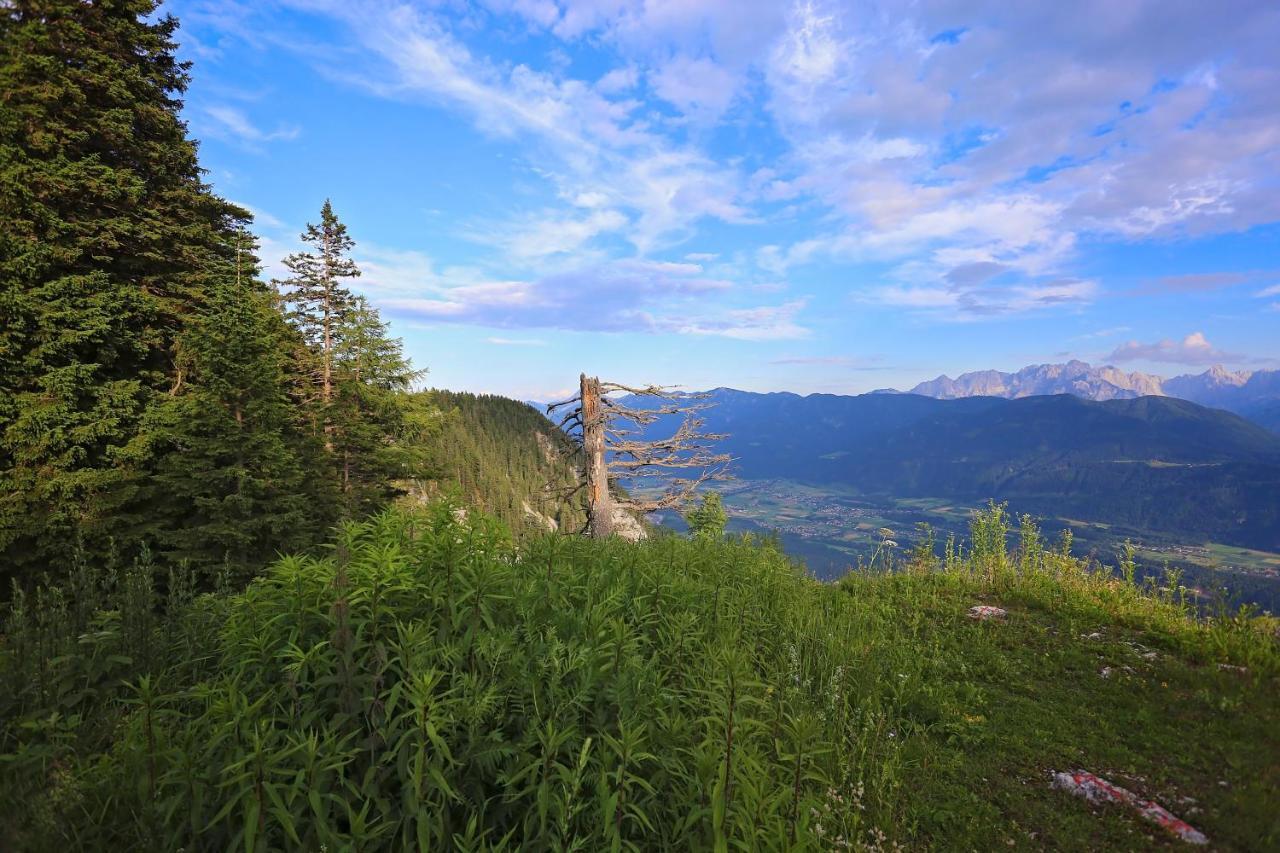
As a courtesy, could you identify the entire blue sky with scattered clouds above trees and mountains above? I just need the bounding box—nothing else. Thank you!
[166,0,1280,398]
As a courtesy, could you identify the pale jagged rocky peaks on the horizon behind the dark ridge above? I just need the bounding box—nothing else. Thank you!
[910,360,1280,432]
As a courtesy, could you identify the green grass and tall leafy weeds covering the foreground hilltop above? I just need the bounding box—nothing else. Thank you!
[0,503,1280,850]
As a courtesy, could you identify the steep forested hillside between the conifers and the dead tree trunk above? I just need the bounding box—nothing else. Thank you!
[420,391,586,538]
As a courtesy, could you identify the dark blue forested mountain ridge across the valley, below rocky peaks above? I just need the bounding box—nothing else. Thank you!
[629,388,1280,551]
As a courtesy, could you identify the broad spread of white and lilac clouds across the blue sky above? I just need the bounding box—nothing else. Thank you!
[220,0,1280,346]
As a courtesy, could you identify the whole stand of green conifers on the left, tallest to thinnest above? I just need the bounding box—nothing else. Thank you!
[0,0,434,587]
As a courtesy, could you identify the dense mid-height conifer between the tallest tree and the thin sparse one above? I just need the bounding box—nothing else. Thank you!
[147,229,324,573]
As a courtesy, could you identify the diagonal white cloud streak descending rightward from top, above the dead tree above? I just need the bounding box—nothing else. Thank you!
[316,4,750,254]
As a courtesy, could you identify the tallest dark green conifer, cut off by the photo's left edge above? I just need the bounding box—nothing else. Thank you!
[0,0,247,566]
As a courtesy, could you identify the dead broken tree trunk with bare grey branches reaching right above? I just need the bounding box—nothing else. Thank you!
[547,373,731,539]
